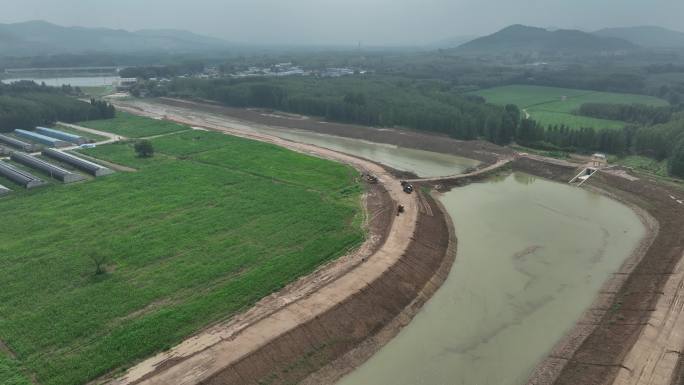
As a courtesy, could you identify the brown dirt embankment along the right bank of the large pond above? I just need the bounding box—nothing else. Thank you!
[513,159,684,385]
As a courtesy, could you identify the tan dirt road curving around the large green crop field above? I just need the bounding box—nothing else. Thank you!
[100,103,454,385]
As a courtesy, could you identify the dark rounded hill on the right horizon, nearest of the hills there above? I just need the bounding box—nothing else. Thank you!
[454,25,639,55]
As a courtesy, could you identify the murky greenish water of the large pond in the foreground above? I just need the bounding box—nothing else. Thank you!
[340,173,645,385]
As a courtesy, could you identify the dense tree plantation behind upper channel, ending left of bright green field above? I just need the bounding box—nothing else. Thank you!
[162,77,520,144]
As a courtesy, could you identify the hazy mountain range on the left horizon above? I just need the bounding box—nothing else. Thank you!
[0,21,231,56]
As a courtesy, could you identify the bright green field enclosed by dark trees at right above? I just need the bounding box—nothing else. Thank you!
[472,86,668,129]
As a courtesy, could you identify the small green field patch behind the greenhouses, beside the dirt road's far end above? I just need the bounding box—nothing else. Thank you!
[77,112,189,138]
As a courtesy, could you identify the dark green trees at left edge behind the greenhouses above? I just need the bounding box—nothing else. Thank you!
[0,82,115,132]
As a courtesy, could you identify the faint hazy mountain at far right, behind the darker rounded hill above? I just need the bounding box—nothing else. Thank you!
[594,26,684,48]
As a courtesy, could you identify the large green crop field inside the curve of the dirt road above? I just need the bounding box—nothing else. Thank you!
[0,121,364,385]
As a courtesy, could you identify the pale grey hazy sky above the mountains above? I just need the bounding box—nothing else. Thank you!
[0,0,684,45]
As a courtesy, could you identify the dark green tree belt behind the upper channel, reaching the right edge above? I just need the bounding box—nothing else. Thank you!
[156,77,684,176]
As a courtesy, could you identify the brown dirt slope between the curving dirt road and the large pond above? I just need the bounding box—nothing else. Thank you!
[195,194,453,385]
